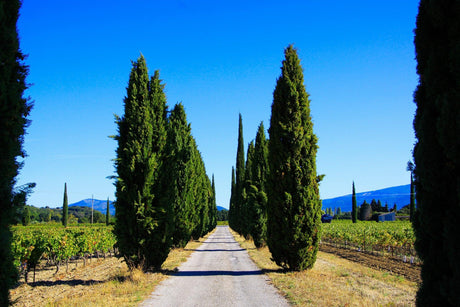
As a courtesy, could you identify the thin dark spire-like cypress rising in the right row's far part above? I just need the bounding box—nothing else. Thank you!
[233,114,245,234]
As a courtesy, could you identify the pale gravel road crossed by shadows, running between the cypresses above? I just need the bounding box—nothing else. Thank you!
[140,226,289,307]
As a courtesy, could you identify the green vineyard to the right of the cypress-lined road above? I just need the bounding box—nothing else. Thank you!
[322,221,418,263]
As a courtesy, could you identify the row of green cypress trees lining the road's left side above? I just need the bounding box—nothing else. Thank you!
[114,55,217,271]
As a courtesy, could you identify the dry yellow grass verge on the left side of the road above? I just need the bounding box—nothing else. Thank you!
[10,234,214,307]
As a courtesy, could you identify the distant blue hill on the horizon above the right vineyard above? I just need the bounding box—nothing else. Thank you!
[323,184,410,212]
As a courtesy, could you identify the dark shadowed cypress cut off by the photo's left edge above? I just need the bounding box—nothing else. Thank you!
[0,0,32,306]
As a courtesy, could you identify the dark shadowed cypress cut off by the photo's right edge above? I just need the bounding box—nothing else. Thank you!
[413,0,460,306]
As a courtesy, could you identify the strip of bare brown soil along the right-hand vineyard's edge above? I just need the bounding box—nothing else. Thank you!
[319,243,422,283]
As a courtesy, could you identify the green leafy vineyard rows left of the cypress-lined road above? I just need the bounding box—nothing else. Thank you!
[12,225,116,283]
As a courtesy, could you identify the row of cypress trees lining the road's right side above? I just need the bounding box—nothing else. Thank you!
[229,45,323,270]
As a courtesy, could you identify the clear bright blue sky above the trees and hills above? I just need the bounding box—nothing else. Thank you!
[18,0,418,207]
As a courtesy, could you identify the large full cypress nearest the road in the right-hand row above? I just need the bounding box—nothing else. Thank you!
[267,45,321,270]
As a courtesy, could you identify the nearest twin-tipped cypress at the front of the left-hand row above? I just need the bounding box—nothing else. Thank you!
[114,55,173,271]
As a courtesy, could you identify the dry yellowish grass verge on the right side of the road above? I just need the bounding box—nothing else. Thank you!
[231,230,418,306]
